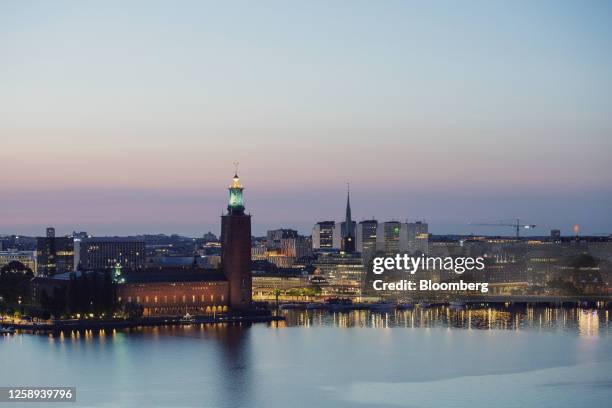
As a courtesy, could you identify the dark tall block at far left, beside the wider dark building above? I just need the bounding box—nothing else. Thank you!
[36,227,74,276]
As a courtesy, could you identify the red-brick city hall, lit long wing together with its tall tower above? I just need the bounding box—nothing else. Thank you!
[117,171,252,316]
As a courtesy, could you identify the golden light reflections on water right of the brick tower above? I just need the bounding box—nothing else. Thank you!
[280,306,610,336]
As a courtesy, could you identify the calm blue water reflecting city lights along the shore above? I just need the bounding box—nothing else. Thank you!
[0,307,612,408]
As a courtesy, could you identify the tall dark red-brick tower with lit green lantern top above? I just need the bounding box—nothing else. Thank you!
[221,172,252,311]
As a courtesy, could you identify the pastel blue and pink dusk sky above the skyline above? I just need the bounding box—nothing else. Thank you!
[0,0,612,236]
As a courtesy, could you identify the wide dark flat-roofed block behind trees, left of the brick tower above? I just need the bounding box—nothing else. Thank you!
[79,237,145,270]
